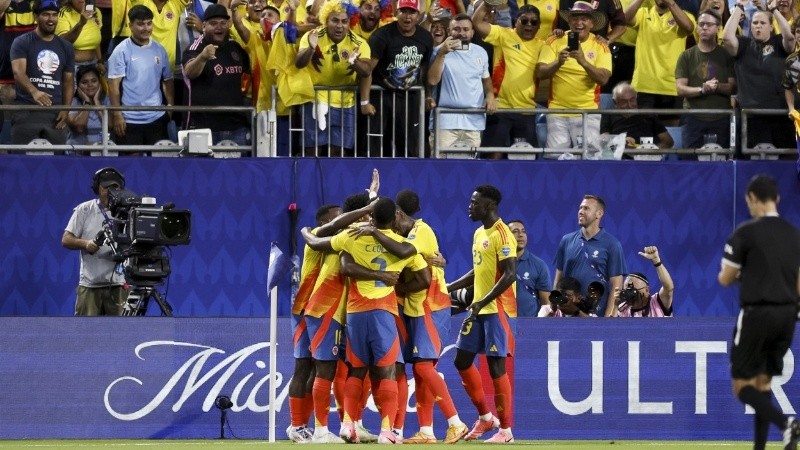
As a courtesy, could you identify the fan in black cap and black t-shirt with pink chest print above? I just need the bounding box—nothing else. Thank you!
[182,4,250,145]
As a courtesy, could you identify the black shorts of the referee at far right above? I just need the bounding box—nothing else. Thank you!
[731,305,797,380]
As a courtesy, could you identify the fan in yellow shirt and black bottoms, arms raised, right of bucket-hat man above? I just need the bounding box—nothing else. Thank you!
[625,0,695,125]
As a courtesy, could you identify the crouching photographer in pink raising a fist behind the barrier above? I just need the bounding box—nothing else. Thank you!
[614,245,675,317]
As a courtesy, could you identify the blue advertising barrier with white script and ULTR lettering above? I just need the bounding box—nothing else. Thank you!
[0,316,800,440]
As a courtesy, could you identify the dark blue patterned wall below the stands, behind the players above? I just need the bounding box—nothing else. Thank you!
[0,155,800,317]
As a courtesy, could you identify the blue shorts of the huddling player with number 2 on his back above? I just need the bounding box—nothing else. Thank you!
[346,309,403,367]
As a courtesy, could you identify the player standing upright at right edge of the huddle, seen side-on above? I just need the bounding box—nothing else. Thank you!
[447,185,517,444]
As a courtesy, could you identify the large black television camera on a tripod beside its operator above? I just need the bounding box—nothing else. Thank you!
[95,189,191,316]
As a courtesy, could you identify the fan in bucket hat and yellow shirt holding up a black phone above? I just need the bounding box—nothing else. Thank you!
[536,1,611,148]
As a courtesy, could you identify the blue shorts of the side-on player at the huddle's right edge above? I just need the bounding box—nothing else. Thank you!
[456,313,517,357]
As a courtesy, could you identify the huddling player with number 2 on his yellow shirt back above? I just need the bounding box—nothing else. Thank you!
[331,197,431,443]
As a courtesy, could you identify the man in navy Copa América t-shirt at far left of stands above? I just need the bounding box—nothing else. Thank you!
[10,0,75,145]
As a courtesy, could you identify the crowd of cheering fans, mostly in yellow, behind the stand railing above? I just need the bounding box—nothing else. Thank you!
[0,0,800,158]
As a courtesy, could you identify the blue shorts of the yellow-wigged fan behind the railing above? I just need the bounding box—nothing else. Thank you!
[303,103,356,148]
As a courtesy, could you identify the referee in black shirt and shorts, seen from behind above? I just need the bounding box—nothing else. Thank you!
[717,175,800,450]
